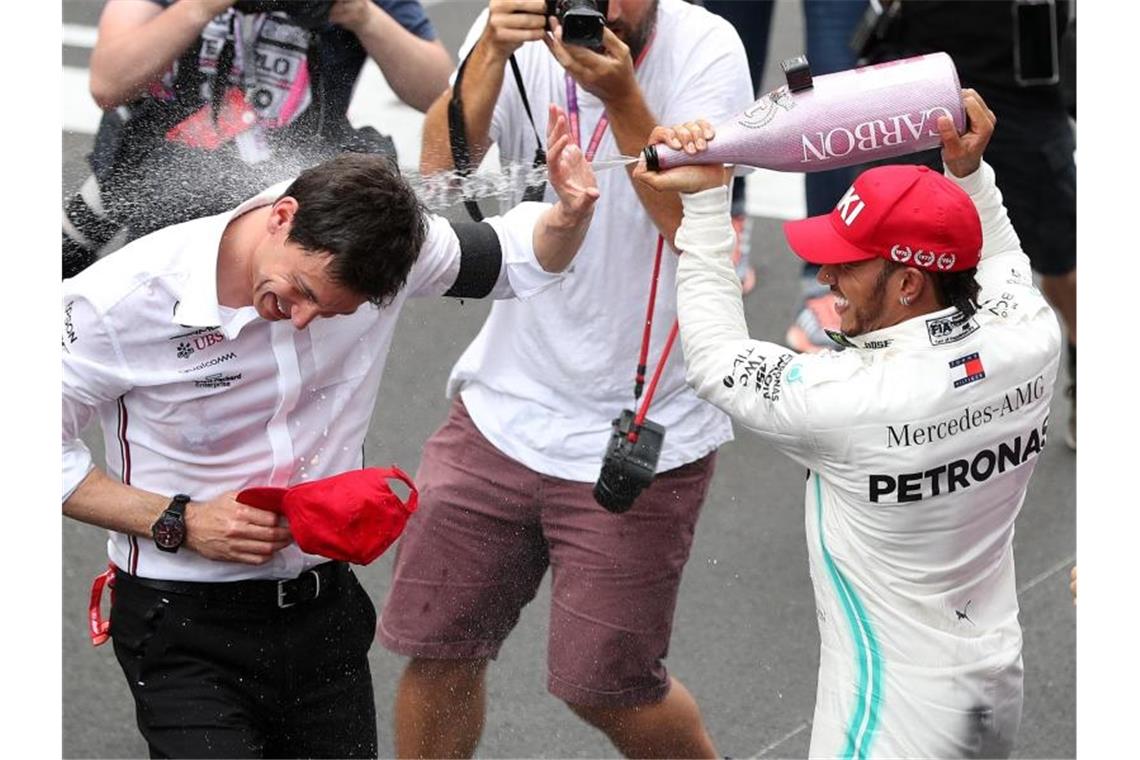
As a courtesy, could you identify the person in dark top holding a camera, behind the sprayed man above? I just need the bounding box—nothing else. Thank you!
[63,0,451,278]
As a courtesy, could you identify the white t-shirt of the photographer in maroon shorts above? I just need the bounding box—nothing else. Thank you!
[448,0,754,482]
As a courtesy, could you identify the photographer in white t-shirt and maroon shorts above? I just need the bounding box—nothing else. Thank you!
[380,0,752,757]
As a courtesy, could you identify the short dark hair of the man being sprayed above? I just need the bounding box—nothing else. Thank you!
[282,153,428,307]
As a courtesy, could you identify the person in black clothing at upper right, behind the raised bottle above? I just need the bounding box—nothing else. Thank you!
[861,0,1076,450]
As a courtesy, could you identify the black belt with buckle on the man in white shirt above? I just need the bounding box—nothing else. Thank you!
[114,562,352,610]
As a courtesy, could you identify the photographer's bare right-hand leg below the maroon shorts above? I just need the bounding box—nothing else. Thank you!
[569,677,719,758]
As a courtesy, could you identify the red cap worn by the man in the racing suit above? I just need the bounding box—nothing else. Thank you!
[784,165,982,272]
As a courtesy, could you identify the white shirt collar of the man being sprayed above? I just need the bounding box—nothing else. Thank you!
[171,180,292,340]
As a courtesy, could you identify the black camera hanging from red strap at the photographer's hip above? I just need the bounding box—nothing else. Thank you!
[594,409,665,514]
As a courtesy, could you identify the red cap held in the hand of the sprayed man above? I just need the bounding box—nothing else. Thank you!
[237,467,418,565]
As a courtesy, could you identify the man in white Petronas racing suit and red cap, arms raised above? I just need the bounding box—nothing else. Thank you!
[638,90,1060,758]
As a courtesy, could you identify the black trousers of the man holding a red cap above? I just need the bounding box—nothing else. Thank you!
[111,563,377,758]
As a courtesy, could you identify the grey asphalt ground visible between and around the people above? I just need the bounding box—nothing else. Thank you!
[62,1,1076,758]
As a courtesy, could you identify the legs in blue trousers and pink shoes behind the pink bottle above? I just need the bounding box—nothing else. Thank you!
[702,0,868,352]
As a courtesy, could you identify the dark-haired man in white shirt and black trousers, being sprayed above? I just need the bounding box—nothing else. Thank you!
[63,111,597,758]
